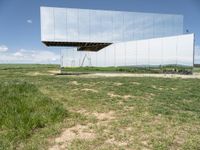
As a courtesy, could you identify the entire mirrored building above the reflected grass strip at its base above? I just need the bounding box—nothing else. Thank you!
[41,7,194,67]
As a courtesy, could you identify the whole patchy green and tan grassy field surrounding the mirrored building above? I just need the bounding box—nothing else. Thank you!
[0,65,200,150]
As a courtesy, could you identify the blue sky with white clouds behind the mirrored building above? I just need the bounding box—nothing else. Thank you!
[0,0,200,63]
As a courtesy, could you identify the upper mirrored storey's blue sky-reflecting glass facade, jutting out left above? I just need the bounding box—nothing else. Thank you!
[41,7,183,43]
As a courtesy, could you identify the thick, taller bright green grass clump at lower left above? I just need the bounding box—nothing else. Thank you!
[0,80,68,149]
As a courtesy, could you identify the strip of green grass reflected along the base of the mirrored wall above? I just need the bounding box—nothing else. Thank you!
[61,66,193,74]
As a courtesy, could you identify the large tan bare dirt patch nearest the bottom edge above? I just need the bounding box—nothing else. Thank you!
[49,125,96,150]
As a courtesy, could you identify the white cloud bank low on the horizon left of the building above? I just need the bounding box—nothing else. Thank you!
[0,49,60,64]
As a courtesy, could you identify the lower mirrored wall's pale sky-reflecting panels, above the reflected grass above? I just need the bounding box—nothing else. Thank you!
[61,34,194,67]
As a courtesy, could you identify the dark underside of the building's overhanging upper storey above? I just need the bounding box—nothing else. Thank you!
[42,41,112,52]
